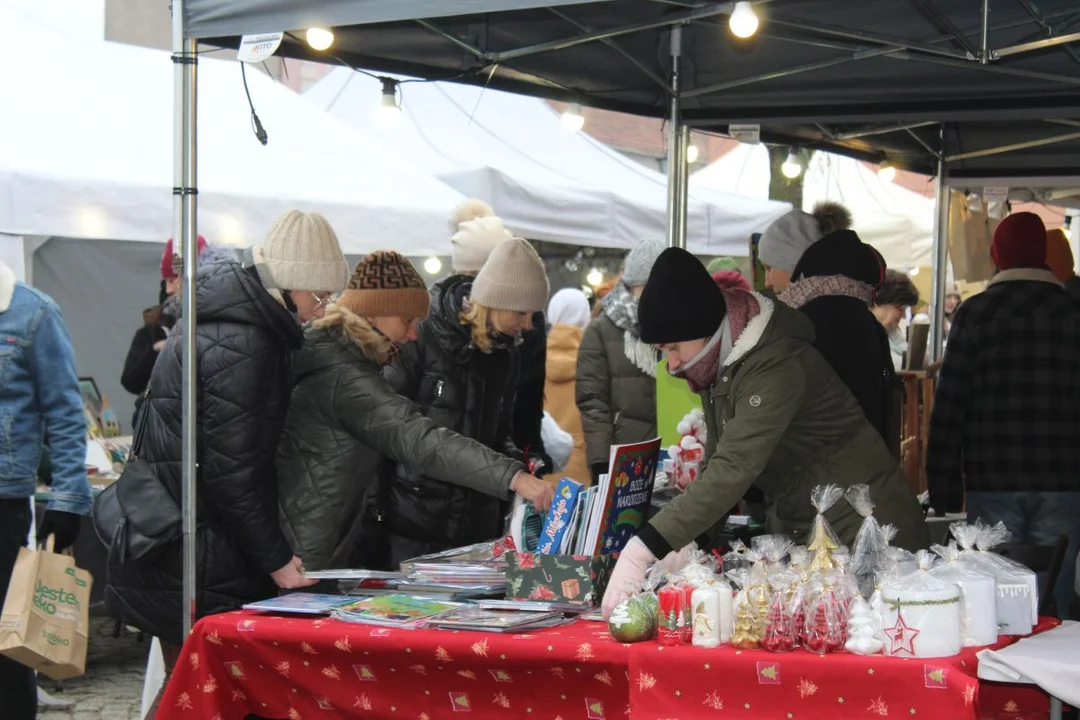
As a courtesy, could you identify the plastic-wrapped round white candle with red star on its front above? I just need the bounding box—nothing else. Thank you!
[881,551,962,657]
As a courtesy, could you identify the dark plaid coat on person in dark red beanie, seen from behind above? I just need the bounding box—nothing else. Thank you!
[927,270,1080,512]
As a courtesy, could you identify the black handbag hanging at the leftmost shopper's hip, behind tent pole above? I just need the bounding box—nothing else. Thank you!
[93,391,181,565]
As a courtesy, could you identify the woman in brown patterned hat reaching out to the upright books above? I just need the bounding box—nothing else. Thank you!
[276,252,552,569]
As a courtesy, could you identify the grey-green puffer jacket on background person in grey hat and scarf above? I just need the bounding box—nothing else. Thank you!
[576,314,657,467]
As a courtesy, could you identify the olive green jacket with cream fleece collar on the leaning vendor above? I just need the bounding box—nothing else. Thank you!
[642,295,928,556]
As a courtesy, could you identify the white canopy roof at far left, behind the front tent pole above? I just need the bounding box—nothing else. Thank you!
[0,8,463,256]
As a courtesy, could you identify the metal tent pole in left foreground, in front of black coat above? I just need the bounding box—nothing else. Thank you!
[173,0,199,637]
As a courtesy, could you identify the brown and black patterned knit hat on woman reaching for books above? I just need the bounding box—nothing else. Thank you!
[337,250,431,320]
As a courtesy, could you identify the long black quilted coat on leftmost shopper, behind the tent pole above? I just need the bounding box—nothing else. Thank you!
[106,261,302,644]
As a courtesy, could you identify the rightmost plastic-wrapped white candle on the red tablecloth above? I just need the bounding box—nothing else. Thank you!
[949,522,1039,635]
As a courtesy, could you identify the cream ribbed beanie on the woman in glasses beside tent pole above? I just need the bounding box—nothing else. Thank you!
[258,210,349,293]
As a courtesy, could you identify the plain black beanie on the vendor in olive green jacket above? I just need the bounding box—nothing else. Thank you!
[637,247,727,345]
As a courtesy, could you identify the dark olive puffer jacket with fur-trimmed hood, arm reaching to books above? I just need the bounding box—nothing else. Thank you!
[276,307,524,570]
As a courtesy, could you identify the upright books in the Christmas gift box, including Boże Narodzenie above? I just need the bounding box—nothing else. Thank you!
[537,438,660,555]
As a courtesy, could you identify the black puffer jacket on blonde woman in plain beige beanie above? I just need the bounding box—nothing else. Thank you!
[382,277,522,566]
